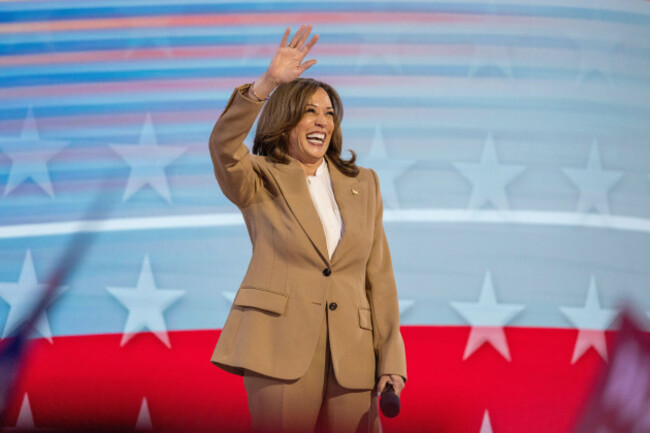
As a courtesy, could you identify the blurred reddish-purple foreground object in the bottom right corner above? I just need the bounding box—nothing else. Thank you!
[575,308,650,433]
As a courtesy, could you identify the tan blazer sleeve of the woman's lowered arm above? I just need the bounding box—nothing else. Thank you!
[366,170,406,381]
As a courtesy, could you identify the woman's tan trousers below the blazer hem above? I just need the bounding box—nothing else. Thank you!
[244,308,381,433]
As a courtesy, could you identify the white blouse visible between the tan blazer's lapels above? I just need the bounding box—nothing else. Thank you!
[307,159,343,259]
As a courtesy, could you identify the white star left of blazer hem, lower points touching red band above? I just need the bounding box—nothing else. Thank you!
[106,255,185,347]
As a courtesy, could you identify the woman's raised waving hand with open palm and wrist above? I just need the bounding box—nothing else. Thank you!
[252,25,318,98]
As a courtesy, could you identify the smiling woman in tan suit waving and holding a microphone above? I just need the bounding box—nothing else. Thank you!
[210,26,406,432]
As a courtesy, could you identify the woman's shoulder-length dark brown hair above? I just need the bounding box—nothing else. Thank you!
[253,78,359,177]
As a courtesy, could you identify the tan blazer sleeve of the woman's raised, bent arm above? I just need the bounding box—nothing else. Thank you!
[210,84,264,208]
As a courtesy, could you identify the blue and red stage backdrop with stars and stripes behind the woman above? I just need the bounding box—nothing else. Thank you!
[0,0,650,433]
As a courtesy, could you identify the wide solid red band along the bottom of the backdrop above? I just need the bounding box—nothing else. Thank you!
[2,327,611,433]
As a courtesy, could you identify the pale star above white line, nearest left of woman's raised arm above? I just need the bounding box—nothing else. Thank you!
[111,114,186,203]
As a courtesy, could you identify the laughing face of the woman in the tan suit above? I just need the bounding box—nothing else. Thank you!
[289,87,334,164]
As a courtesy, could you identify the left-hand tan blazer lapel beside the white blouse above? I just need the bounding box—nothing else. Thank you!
[274,159,330,264]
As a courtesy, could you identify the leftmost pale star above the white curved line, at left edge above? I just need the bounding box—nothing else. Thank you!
[0,106,70,197]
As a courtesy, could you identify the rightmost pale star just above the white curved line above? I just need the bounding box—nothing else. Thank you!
[563,140,623,215]
